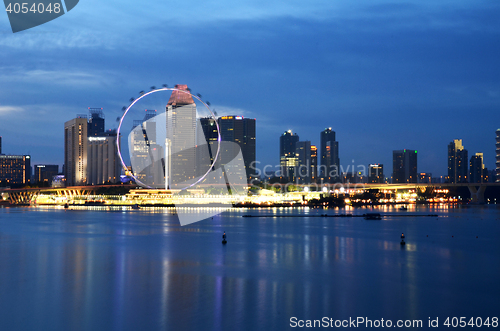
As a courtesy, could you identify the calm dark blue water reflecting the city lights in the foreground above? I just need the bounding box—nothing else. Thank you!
[0,206,500,330]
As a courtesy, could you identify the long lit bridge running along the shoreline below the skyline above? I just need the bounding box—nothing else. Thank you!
[0,183,500,204]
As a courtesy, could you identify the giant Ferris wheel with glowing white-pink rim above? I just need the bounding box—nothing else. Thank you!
[117,85,221,190]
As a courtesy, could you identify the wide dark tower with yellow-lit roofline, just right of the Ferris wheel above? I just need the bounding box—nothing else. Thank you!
[218,116,256,181]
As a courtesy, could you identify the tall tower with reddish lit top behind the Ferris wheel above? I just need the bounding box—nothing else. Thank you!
[166,84,196,188]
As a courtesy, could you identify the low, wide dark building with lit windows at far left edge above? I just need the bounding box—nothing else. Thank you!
[0,154,31,186]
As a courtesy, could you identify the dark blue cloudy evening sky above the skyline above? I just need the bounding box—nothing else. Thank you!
[0,0,500,176]
